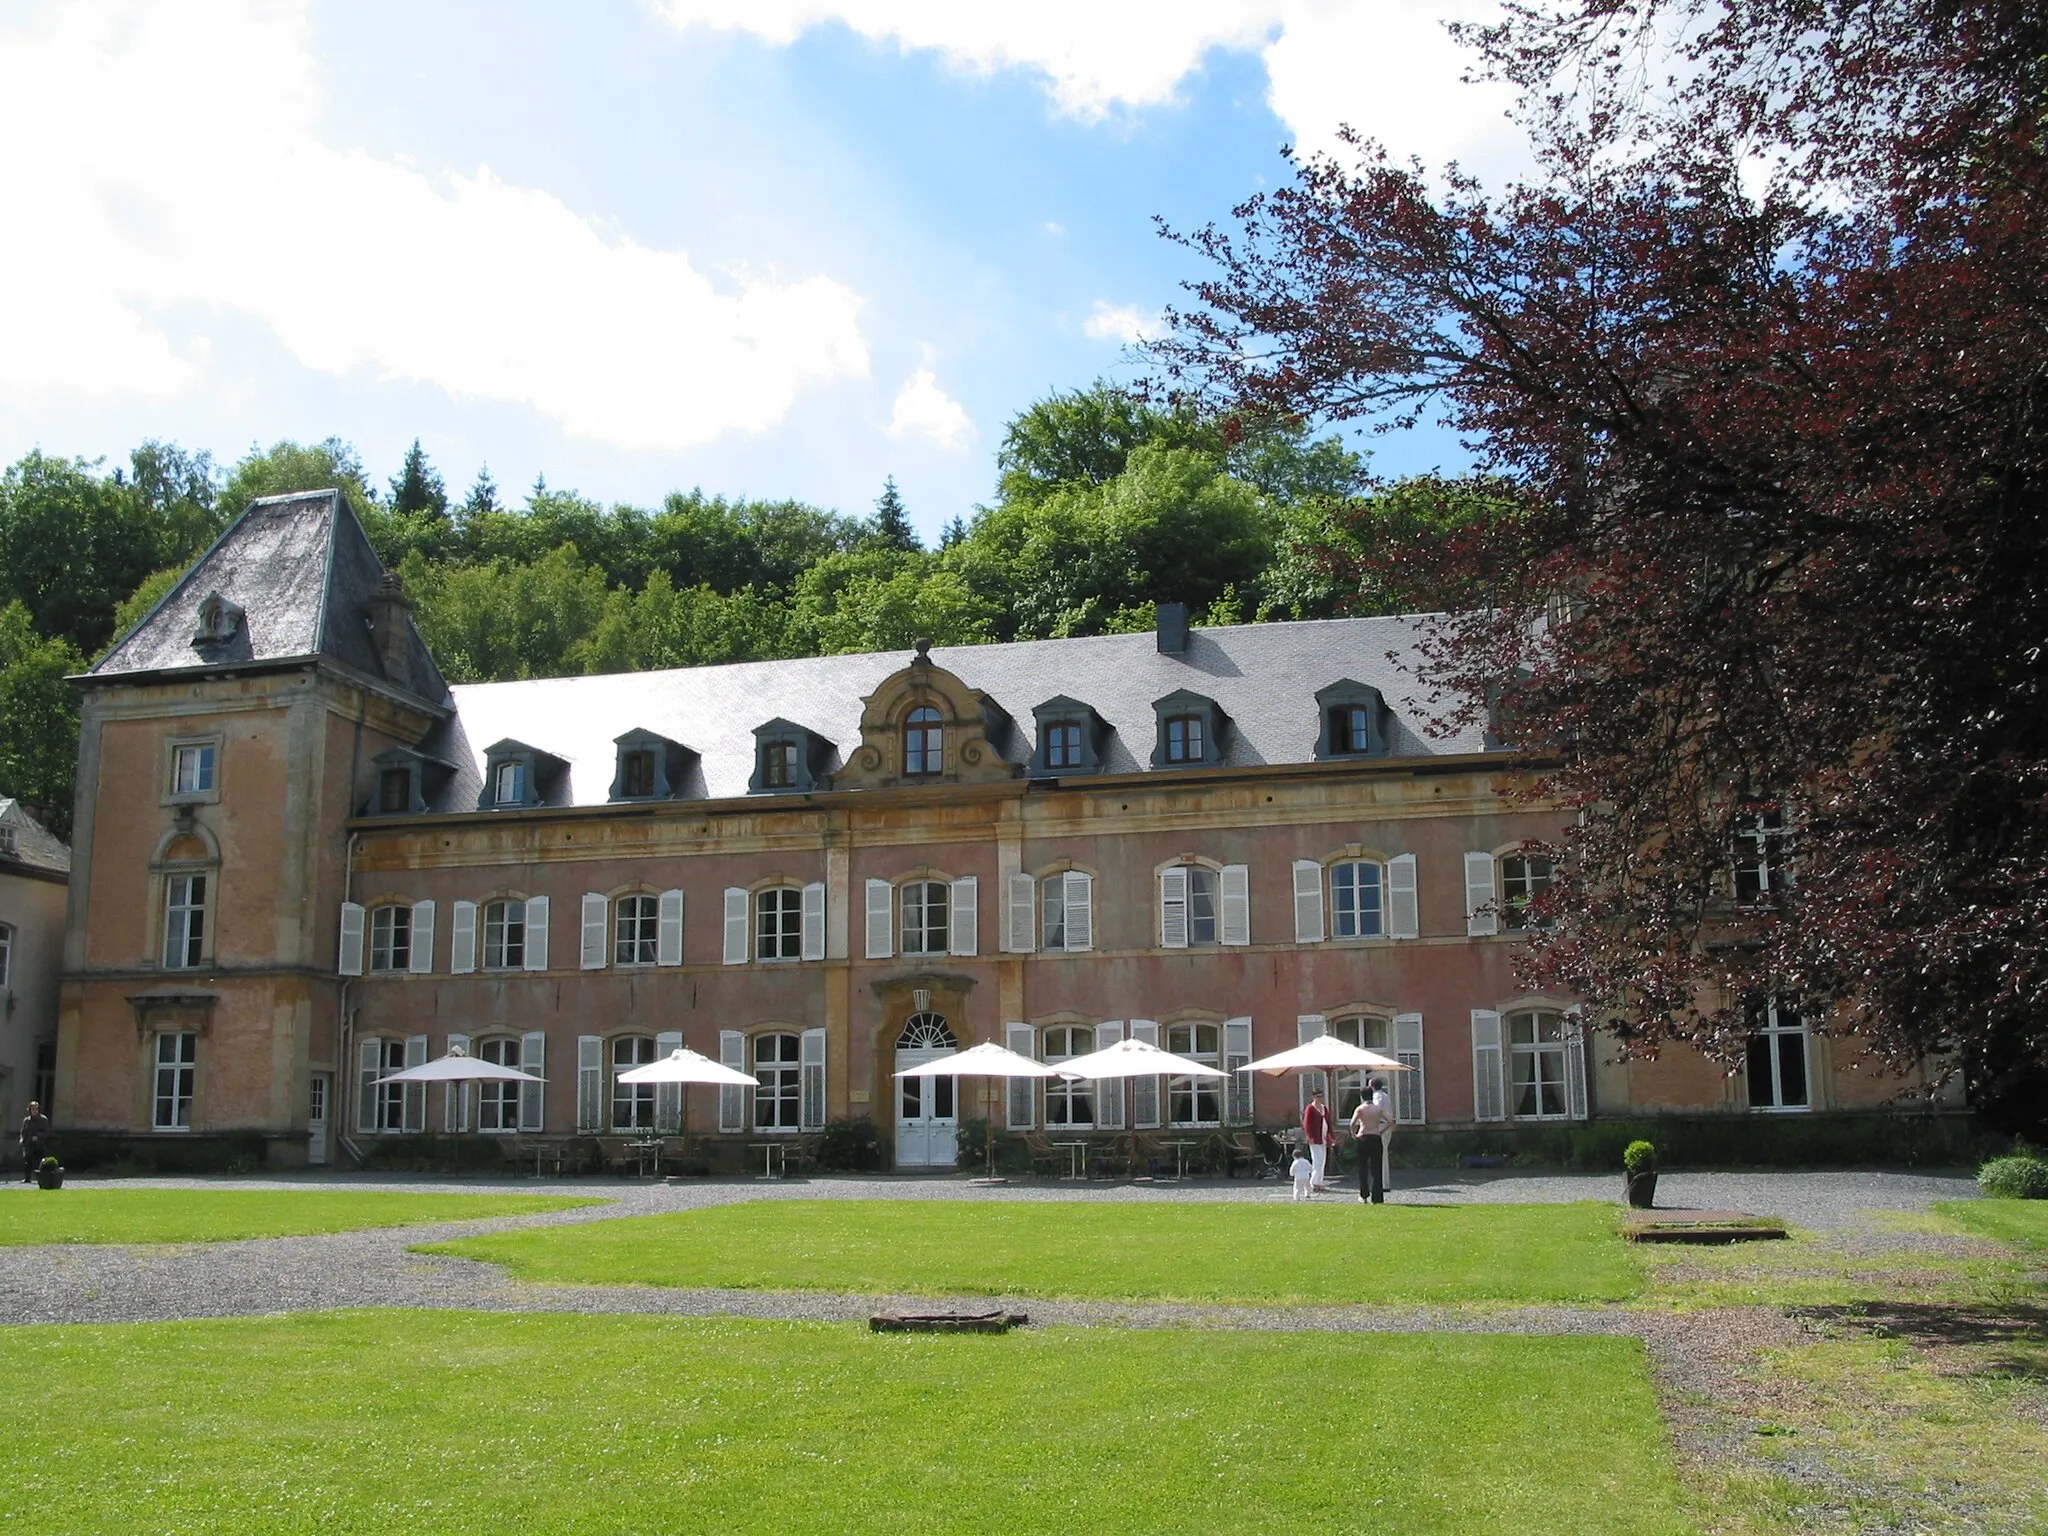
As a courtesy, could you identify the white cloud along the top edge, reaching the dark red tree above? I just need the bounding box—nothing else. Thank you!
[659,0,1522,166]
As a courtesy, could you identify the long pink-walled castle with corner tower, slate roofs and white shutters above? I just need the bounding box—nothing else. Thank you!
[55,492,1933,1167]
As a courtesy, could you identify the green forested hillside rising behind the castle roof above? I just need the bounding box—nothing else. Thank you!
[0,385,1507,834]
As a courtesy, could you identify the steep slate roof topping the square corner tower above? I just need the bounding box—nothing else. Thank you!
[86,492,449,705]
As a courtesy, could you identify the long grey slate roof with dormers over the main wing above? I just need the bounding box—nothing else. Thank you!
[436,614,1487,811]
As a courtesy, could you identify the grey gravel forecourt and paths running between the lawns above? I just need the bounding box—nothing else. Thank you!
[0,1169,1974,1354]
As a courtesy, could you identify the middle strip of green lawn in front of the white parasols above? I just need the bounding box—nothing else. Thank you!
[426,1200,1642,1303]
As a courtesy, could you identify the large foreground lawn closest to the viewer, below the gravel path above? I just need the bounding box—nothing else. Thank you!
[0,1311,1688,1536]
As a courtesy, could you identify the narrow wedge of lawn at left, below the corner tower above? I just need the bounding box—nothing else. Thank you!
[0,1188,602,1245]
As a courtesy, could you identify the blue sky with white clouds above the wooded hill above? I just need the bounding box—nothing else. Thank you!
[0,0,1520,535]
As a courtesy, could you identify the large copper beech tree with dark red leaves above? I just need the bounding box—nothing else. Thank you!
[1157,0,2048,1126]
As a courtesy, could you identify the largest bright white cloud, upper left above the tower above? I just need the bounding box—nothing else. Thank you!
[0,0,868,449]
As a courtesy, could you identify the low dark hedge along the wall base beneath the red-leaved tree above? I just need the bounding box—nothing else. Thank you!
[1359,1114,2003,1171]
